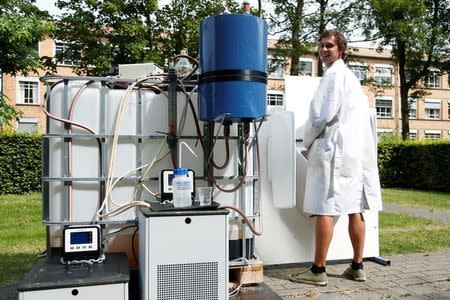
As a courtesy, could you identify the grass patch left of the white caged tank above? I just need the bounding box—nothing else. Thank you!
[0,193,45,284]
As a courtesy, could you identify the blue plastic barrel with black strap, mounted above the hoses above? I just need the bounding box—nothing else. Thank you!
[199,14,267,123]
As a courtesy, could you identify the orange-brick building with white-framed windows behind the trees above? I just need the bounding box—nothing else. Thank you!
[0,39,450,139]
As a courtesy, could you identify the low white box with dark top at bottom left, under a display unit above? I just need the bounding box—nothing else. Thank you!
[17,253,130,300]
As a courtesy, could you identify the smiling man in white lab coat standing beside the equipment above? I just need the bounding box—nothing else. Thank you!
[290,30,382,285]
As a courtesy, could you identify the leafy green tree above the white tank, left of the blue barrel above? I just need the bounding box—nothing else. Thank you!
[56,0,243,76]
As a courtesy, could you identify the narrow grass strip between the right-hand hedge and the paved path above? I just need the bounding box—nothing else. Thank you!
[382,188,450,211]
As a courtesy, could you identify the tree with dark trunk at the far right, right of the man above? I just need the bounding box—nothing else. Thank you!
[366,0,450,139]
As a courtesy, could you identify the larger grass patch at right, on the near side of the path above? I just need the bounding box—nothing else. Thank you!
[380,212,450,255]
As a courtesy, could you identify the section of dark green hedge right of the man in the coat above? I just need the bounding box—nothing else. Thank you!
[378,138,450,192]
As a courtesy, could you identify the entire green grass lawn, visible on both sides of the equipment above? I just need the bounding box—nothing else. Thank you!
[0,189,450,285]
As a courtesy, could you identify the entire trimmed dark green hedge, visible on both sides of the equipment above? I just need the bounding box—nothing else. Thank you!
[0,133,450,194]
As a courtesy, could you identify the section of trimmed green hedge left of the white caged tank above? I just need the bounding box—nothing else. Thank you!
[0,133,42,194]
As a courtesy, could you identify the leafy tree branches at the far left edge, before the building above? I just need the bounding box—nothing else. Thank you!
[0,0,54,130]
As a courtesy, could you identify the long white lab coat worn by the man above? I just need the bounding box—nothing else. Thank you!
[303,59,382,215]
